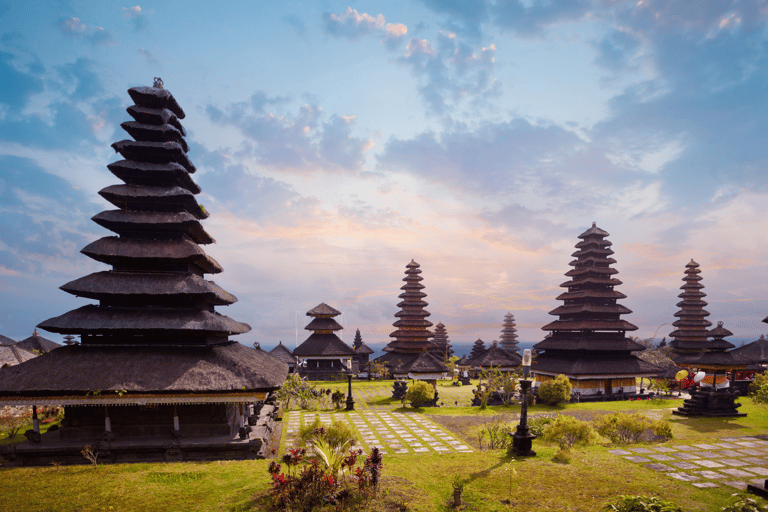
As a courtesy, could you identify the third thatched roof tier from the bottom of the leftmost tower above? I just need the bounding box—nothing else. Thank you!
[60,271,237,306]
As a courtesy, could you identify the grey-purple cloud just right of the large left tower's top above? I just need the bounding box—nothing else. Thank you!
[206,92,373,173]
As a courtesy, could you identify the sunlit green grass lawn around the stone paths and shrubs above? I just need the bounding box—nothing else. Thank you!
[0,381,768,512]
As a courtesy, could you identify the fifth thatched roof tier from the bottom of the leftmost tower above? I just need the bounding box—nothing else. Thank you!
[91,210,216,244]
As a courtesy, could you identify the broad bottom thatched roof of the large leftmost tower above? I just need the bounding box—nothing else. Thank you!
[0,342,288,394]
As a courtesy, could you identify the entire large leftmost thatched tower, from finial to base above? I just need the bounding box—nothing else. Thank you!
[0,83,288,462]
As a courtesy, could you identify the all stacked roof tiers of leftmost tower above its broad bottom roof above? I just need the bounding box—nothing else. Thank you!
[39,83,251,346]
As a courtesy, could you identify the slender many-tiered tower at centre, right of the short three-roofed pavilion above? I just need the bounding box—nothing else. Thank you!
[376,260,448,401]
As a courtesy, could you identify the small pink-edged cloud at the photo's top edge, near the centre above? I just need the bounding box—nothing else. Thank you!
[323,7,408,50]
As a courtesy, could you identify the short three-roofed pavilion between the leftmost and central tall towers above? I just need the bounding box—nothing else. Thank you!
[293,303,355,380]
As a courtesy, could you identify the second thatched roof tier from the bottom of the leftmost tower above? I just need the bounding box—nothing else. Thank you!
[39,304,251,336]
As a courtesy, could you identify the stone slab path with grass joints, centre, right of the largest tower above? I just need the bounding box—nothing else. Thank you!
[283,410,473,454]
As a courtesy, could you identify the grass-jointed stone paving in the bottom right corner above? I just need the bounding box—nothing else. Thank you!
[608,437,768,490]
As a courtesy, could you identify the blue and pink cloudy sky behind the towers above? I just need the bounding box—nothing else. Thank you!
[0,0,768,348]
